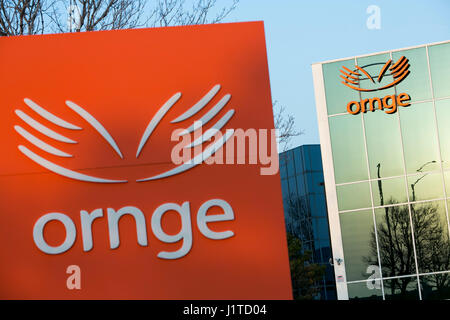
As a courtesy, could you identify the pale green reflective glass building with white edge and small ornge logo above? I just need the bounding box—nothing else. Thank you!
[313,41,450,300]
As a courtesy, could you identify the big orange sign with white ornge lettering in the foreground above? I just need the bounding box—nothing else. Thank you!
[0,22,292,299]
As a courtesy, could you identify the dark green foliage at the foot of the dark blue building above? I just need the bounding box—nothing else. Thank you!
[287,233,325,300]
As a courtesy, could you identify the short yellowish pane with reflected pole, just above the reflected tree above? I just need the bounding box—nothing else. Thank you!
[372,177,408,206]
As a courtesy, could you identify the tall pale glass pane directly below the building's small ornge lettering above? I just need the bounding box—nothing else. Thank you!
[364,112,404,179]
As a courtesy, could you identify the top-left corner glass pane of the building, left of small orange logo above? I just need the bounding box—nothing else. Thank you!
[322,59,359,115]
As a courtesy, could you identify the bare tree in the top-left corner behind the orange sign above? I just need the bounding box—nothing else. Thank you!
[0,0,53,36]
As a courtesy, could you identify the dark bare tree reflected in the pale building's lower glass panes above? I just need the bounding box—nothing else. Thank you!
[365,198,450,296]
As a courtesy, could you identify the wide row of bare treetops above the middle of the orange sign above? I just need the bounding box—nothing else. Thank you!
[49,0,239,32]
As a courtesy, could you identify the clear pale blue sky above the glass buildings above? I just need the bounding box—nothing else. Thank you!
[218,0,450,147]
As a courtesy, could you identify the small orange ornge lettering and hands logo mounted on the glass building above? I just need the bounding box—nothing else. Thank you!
[339,56,411,115]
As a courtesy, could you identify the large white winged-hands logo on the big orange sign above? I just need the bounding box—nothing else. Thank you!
[14,85,235,183]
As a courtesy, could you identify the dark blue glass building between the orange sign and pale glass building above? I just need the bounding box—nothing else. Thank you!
[280,145,336,300]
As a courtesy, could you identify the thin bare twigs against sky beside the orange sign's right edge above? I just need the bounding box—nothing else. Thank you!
[273,101,304,151]
